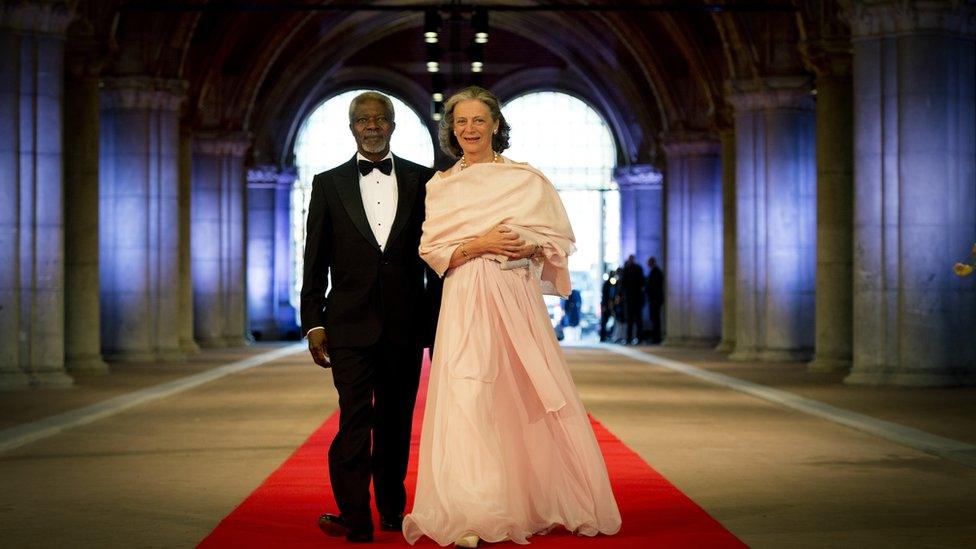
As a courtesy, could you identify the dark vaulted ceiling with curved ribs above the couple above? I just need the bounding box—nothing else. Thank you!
[68,0,844,164]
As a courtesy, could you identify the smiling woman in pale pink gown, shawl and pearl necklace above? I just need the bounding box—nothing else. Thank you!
[403,87,620,547]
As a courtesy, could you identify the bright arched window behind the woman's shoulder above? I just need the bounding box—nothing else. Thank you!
[502,91,620,338]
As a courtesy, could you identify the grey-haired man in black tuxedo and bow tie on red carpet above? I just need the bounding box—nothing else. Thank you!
[301,92,440,543]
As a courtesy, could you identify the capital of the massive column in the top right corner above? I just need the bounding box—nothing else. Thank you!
[850,0,976,40]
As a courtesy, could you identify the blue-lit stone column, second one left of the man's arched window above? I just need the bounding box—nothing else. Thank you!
[191,135,250,347]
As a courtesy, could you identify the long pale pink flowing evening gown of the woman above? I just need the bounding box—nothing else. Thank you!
[403,158,620,545]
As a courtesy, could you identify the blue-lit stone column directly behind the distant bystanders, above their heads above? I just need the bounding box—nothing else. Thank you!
[613,164,664,265]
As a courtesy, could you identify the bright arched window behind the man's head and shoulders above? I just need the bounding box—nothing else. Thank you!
[291,90,434,309]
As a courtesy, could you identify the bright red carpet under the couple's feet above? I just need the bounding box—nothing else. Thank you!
[200,354,744,549]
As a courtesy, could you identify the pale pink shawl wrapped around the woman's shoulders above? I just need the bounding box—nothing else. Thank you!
[420,161,576,297]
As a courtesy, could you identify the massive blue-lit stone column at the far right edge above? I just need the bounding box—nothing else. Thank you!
[845,0,976,386]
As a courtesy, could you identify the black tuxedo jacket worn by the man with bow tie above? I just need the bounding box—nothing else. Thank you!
[301,156,440,347]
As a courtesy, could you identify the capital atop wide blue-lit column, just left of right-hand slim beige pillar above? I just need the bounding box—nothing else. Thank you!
[725,75,814,112]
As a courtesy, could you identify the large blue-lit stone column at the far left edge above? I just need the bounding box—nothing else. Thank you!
[0,2,73,390]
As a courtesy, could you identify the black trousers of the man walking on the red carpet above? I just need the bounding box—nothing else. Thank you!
[329,343,423,531]
